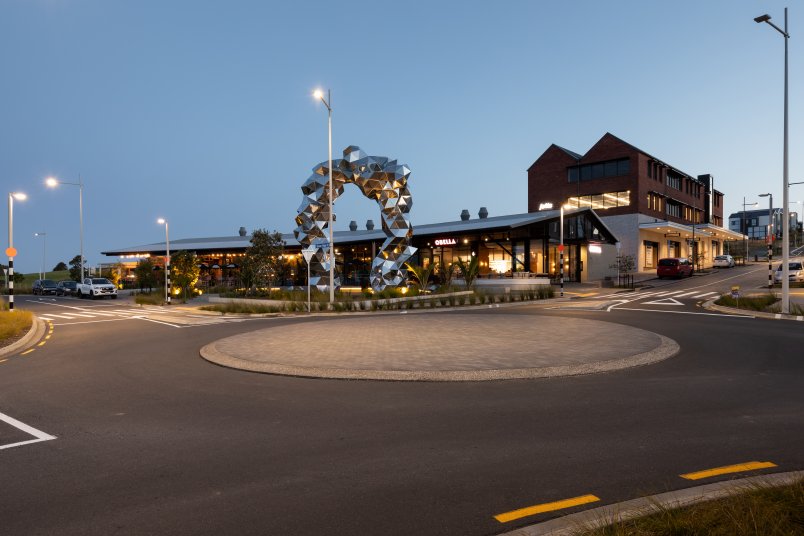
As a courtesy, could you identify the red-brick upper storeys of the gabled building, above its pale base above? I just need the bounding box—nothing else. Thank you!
[528,133,723,226]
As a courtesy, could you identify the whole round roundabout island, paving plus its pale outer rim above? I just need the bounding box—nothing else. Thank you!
[201,313,679,381]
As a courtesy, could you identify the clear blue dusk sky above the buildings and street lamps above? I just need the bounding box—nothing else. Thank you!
[0,0,804,272]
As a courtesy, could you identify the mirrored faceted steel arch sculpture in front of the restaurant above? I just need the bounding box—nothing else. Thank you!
[293,145,416,291]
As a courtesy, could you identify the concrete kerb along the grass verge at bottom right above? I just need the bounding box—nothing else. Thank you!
[501,471,804,536]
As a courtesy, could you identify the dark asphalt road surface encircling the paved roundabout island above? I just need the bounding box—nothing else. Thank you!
[0,267,804,535]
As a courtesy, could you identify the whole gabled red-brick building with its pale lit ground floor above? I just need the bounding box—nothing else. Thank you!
[528,133,743,272]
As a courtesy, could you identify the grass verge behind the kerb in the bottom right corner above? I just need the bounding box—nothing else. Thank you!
[575,480,804,536]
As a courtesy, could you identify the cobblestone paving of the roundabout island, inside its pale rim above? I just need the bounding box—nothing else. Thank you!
[215,314,662,371]
